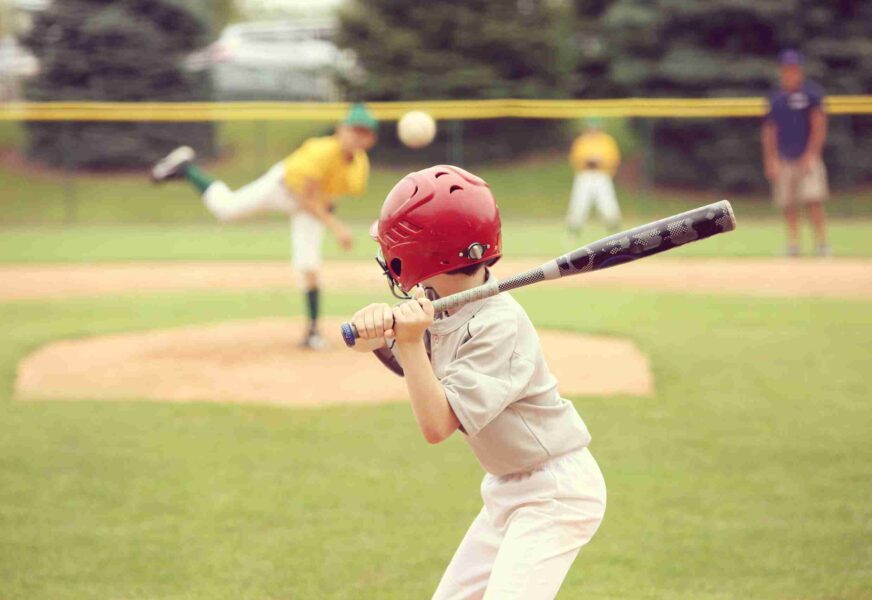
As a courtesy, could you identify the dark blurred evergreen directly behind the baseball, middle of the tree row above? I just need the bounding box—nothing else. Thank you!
[338,0,573,161]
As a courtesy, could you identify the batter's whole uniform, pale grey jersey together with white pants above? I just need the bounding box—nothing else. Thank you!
[390,282,606,600]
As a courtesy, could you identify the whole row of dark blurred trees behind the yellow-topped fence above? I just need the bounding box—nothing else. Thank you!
[0,0,872,192]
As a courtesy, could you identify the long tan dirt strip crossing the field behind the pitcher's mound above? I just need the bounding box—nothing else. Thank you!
[0,258,872,301]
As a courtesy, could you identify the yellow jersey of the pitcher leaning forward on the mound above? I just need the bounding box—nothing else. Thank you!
[284,135,369,201]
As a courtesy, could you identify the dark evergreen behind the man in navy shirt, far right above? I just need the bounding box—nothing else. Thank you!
[600,0,872,189]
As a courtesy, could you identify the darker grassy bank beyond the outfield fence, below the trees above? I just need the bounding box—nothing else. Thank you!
[0,120,872,231]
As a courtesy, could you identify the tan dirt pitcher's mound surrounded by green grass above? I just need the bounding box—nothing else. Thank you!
[15,319,653,406]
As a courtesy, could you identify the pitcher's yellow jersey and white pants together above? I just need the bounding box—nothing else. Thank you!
[203,136,369,272]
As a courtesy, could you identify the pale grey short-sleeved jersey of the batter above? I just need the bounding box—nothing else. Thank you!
[396,276,590,475]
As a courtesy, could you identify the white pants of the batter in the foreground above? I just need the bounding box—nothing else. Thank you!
[433,448,606,600]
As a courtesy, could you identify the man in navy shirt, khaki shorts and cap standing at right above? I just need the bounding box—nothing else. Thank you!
[762,50,830,256]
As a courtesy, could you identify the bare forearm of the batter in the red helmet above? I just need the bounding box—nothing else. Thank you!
[397,341,460,444]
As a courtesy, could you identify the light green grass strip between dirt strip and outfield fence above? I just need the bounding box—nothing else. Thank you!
[0,217,872,263]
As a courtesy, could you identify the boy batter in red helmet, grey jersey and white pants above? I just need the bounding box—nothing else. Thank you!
[352,166,606,600]
